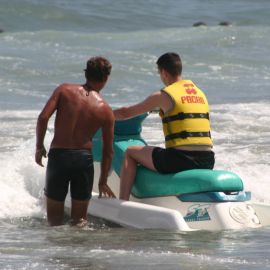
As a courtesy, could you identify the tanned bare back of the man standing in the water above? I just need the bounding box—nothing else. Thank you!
[48,84,114,149]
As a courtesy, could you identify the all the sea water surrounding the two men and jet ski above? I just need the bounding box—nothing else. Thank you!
[0,0,270,270]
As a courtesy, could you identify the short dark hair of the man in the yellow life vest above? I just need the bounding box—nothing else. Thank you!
[157,52,182,76]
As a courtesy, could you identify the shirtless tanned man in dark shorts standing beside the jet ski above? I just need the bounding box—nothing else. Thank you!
[35,57,115,226]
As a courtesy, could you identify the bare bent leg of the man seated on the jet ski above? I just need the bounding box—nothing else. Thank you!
[119,146,156,201]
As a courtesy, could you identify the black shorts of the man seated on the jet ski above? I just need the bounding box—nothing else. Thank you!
[152,147,215,173]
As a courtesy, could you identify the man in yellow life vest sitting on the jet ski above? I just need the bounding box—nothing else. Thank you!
[114,53,215,200]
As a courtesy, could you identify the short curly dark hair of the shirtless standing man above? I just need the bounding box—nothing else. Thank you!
[84,56,112,82]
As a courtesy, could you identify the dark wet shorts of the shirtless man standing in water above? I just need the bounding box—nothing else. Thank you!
[44,148,94,201]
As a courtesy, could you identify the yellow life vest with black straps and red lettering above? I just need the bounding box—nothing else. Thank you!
[160,80,213,148]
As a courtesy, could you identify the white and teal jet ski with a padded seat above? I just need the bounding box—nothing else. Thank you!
[69,114,270,231]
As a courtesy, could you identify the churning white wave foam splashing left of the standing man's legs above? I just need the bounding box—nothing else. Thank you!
[0,142,42,218]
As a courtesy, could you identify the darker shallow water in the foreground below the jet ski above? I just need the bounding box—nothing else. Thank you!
[0,219,270,270]
